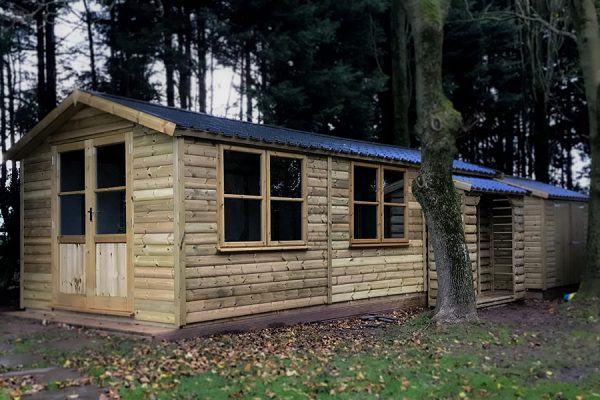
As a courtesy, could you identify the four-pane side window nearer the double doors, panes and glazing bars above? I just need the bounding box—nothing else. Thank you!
[220,148,305,247]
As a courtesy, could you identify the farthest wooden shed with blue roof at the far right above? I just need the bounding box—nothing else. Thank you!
[501,176,588,291]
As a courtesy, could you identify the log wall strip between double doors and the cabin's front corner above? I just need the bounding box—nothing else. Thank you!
[133,125,180,324]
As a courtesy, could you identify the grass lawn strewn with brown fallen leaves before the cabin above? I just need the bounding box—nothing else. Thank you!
[0,302,600,399]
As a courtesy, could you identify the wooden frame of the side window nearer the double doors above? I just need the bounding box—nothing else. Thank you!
[217,145,308,251]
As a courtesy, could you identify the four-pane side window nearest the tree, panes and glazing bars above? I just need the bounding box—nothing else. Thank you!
[351,163,407,244]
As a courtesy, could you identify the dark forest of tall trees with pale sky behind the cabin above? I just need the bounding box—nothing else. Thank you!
[0,0,589,290]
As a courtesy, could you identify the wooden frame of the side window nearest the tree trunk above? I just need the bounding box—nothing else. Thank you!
[350,161,409,247]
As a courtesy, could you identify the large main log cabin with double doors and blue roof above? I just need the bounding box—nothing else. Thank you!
[4,90,496,326]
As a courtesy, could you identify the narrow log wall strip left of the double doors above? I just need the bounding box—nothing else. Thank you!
[21,141,52,309]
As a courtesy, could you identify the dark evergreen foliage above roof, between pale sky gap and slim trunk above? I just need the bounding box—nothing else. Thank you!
[220,0,387,138]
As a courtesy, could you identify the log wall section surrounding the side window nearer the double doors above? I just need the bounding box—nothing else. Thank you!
[183,139,328,323]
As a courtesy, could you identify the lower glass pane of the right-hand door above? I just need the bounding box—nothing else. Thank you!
[96,190,126,234]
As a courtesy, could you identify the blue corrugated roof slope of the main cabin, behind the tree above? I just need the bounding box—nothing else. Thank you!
[90,92,497,175]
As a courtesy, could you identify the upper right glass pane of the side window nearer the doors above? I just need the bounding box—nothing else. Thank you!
[271,157,302,198]
